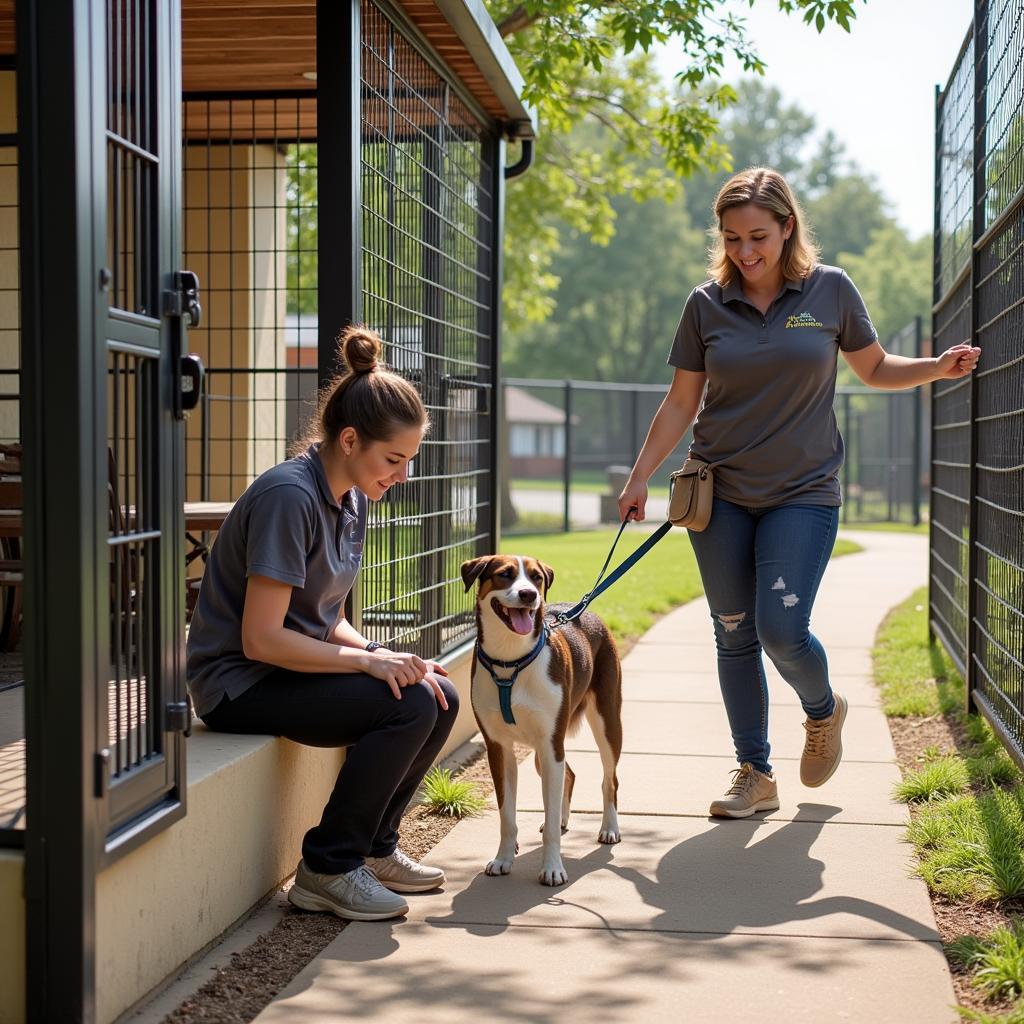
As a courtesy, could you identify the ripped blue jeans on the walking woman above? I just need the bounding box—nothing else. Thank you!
[689,498,839,772]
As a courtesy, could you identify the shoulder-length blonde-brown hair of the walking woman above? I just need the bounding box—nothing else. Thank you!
[708,167,820,288]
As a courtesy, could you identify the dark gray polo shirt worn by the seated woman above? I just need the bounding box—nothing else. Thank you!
[186,444,367,716]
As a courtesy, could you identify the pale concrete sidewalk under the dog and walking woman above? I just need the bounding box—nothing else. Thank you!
[251,532,957,1024]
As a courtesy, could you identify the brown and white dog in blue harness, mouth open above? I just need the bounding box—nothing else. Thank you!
[462,555,623,886]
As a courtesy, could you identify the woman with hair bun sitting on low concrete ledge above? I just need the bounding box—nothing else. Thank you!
[187,328,459,921]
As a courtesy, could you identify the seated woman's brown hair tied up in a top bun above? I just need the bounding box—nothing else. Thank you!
[290,325,430,455]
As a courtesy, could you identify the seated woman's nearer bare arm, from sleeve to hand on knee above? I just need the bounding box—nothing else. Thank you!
[242,575,429,697]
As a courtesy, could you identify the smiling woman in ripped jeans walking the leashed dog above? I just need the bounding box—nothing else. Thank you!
[618,168,980,818]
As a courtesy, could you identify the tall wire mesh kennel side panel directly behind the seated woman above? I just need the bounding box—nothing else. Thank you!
[360,3,497,655]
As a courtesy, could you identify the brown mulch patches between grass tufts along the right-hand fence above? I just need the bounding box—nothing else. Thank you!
[888,715,1024,1014]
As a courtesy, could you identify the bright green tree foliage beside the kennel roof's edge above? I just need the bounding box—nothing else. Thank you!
[487,0,855,328]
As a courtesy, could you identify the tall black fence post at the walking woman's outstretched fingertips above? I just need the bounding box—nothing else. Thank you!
[964,0,988,713]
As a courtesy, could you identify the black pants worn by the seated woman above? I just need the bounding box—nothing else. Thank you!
[203,669,459,874]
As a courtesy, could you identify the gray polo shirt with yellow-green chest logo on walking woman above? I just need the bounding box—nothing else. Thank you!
[669,266,878,508]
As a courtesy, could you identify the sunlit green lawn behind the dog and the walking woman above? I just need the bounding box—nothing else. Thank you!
[502,529,861,642]
